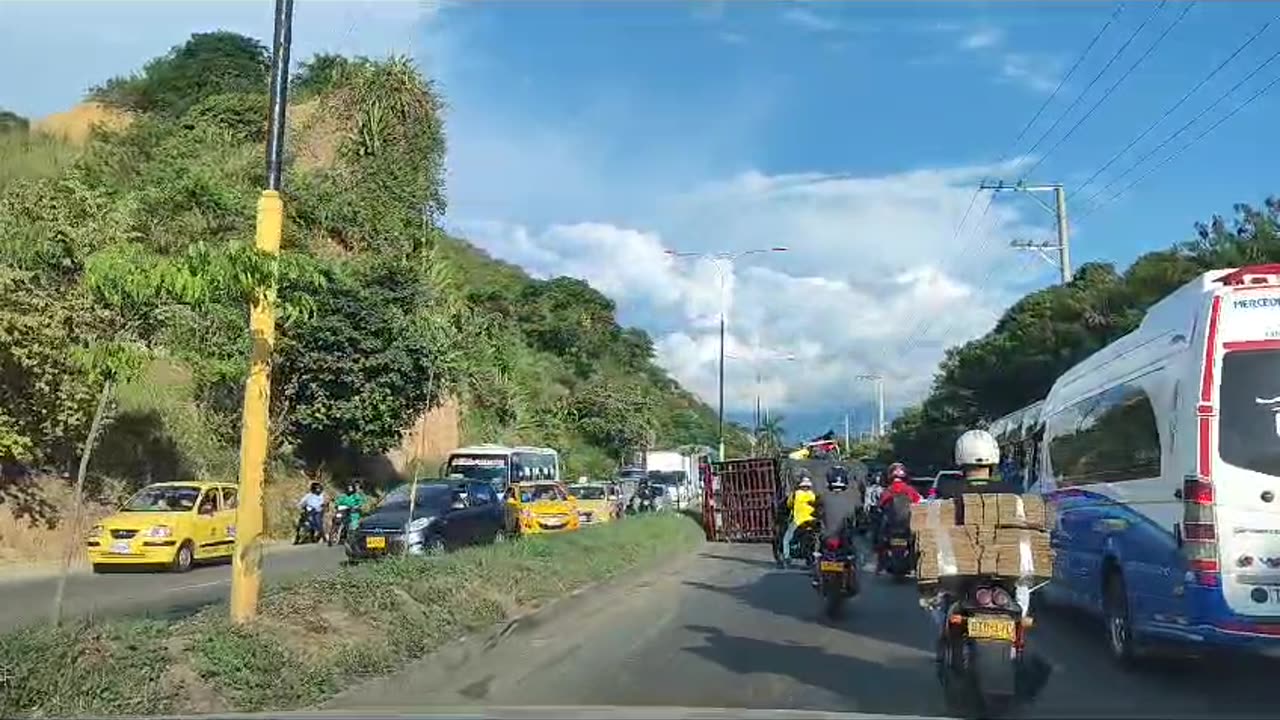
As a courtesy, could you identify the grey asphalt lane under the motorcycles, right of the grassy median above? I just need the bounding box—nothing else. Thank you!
[325,544,1280,717]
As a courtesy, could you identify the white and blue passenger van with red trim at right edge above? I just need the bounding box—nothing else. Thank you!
[1039,264,1280,661]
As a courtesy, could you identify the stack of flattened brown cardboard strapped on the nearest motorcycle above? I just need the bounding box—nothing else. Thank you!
[911,493,1053,587]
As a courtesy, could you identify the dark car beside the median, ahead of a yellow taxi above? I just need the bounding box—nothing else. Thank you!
[347,480,506,560]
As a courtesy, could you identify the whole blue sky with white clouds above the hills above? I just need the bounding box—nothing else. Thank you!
[0,0,1280,432]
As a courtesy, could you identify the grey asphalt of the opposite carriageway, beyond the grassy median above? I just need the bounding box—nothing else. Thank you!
[0,546,346,630]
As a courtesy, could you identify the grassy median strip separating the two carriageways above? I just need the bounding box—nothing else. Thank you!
[0,514,701,717]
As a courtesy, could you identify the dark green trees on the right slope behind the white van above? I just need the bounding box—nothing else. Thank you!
[891,197,1280,470]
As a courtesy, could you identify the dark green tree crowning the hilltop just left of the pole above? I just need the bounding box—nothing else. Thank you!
[90,31,270,118]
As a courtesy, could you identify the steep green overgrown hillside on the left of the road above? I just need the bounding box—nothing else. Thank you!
[0,32,746,561]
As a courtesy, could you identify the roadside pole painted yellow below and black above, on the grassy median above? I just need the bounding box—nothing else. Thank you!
[230,0,293,623]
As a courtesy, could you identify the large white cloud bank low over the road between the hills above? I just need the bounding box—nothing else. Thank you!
[457,156,1021,411]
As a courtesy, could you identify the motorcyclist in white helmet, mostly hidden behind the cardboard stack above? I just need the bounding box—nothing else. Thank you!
[929,429,1052,701]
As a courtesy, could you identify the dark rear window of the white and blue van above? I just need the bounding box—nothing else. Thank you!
[1217,350,1280,475]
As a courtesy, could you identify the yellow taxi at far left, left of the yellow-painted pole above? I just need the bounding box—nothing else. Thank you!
[86,482,236,573]
